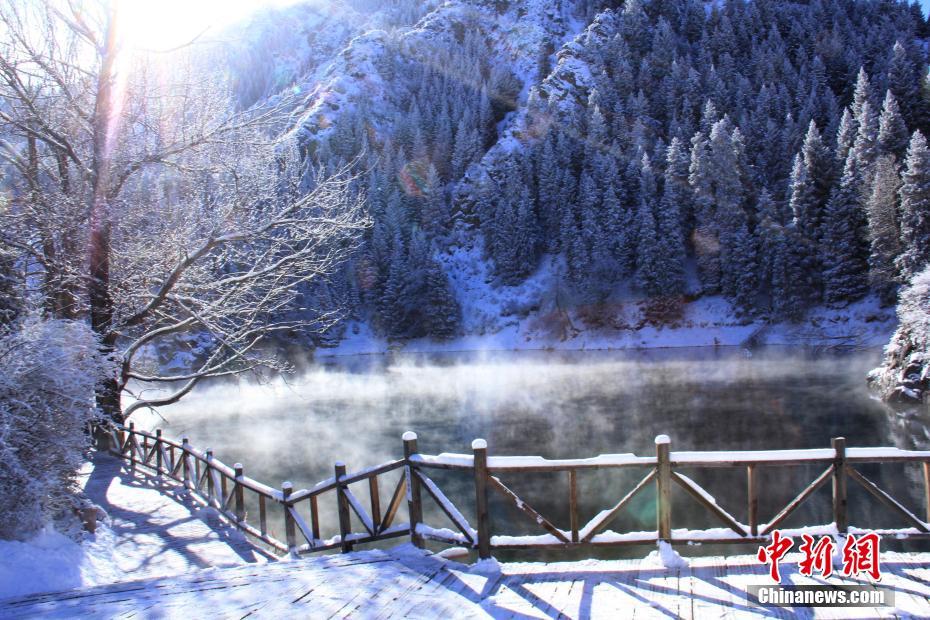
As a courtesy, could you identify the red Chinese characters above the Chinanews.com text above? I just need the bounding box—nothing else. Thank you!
[756,530,882,583]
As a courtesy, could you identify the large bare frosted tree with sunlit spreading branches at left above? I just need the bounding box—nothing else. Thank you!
[0,0,366,419]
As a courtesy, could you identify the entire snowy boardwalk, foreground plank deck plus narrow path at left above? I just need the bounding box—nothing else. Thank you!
[0,456,930,620]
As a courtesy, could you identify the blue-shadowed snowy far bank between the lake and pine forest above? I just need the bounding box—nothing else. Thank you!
[317,246,897,357]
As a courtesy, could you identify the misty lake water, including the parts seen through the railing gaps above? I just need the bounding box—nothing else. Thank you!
[134,349,928,556]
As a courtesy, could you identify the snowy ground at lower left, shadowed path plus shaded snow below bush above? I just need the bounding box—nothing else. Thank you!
[0,455,268,600]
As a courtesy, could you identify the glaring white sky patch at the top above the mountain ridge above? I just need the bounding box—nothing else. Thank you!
[122,0,304,50]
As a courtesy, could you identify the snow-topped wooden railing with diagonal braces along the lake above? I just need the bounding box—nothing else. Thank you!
[101,424,930,558]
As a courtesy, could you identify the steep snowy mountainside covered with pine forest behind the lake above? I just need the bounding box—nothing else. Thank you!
[223,0,930,348]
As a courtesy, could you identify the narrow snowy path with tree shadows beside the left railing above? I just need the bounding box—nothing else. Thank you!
[81,453,267,579]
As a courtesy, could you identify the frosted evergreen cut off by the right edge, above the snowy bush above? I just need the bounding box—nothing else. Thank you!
[897,131,930,282]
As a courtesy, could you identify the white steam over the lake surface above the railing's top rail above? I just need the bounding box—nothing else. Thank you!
[135,349,895,486]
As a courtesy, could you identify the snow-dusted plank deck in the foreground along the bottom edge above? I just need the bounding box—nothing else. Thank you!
[0,545,930,620]
